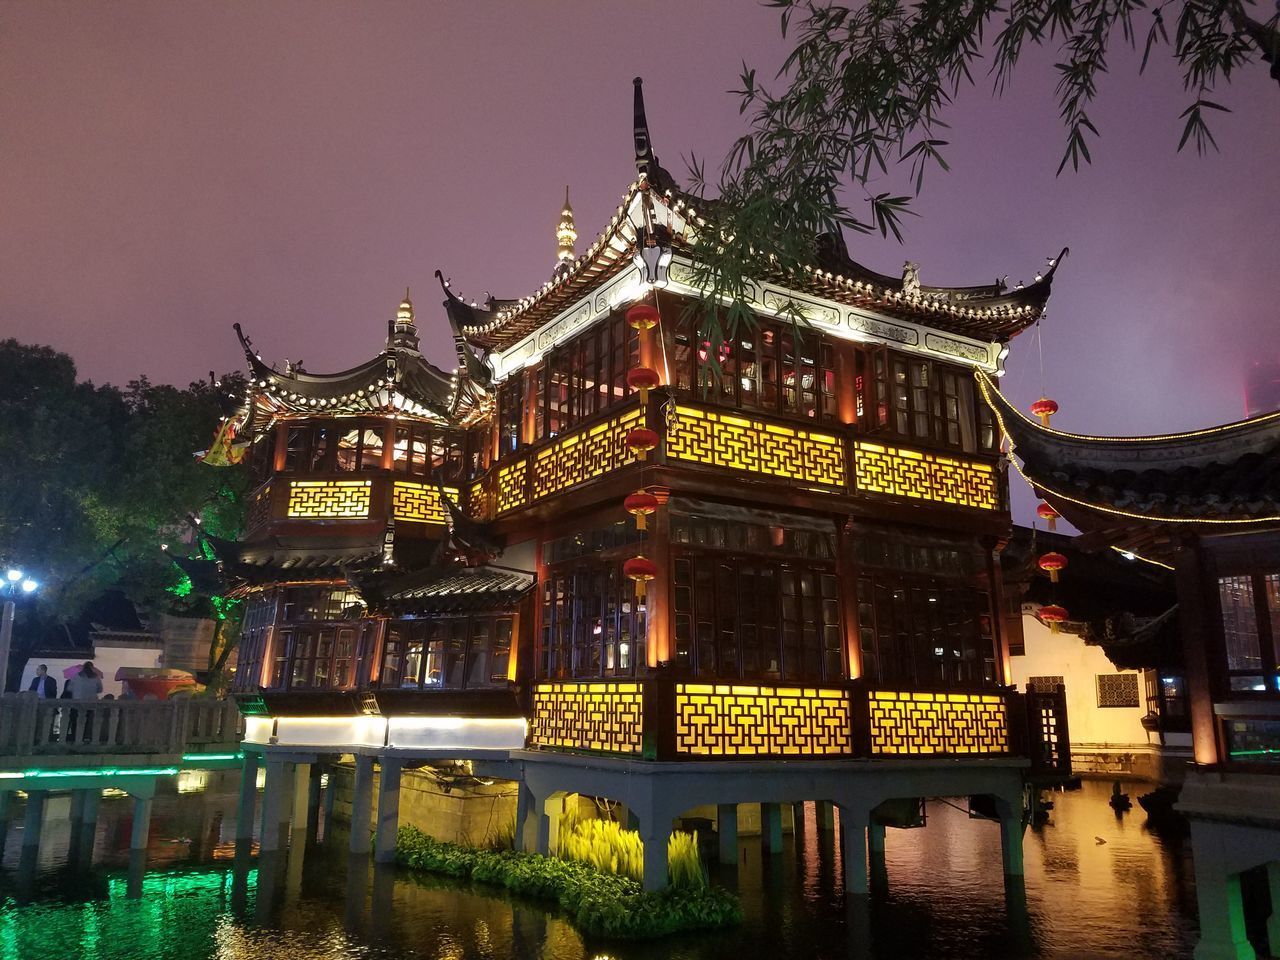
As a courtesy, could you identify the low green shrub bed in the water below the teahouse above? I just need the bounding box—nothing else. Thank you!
[396,824,742,940]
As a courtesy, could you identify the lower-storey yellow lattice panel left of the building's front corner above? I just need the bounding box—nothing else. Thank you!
[529,682,644,754]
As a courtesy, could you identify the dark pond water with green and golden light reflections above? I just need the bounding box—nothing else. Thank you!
[0,782,1196,960]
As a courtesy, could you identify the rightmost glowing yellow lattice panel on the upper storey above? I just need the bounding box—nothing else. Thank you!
[854,440,1000,509]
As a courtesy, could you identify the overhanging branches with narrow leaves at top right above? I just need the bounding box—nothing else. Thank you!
[690,0,1280,342]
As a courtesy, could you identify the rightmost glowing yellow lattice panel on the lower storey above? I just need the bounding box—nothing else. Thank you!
[868,690,1009,756]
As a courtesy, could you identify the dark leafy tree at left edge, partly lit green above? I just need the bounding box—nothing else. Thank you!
[0,339,247,660]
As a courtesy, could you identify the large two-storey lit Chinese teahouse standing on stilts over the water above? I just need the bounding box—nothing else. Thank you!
[215,81,1069,892]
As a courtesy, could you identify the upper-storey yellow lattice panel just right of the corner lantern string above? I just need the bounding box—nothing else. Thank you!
[667,404,845,488]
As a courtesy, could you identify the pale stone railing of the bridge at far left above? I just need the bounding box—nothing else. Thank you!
[0,694,244,764]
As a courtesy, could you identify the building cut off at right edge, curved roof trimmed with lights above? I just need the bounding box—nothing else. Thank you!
[982,379,1280,960]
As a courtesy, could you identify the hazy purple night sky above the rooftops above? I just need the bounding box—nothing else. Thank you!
[0,0,1280,527]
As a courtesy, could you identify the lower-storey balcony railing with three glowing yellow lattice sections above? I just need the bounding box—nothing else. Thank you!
[529,678,1070,772]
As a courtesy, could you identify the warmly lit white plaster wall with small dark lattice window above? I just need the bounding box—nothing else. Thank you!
[1010,613,1158,749]
